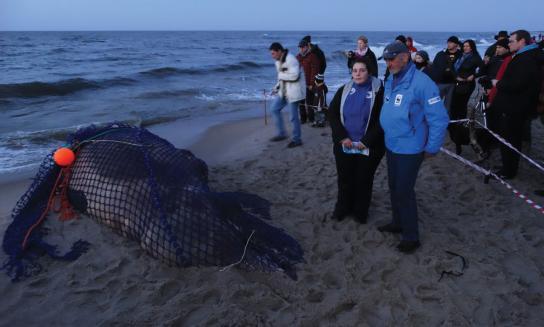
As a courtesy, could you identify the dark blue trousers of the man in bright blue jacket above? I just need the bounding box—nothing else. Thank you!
[387,150,423,241]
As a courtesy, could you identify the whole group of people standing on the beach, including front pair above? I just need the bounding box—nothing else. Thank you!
[269,30,544,253]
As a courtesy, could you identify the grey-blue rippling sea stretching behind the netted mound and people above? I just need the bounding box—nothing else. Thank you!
[0,31,506,175]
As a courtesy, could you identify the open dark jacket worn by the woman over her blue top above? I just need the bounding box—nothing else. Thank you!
[328,78,385,150]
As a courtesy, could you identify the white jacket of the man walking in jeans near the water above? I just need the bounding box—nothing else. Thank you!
[275,50,306,103]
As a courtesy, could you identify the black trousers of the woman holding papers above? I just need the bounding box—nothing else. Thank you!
[333,144,384,220]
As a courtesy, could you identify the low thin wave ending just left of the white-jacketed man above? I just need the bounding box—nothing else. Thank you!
[140,61,269,77]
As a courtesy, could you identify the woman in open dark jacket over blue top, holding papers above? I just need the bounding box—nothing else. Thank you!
[329,58,385,224]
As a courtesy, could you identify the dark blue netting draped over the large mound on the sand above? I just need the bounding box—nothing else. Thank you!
[3,124,303,278]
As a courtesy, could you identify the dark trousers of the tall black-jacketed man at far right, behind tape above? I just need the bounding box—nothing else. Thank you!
[497,114,525,177]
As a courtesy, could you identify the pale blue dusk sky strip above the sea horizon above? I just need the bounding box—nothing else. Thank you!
[0,0,544,31]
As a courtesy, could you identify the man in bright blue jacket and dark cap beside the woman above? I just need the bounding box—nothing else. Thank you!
[378,42,449,253]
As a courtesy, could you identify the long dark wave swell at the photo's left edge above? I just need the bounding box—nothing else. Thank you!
[0,77,135,98]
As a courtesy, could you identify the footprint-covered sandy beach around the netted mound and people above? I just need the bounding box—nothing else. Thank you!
[0,113,544,326]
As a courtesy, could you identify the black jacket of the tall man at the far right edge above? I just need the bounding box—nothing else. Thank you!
[493,48,544,118]
